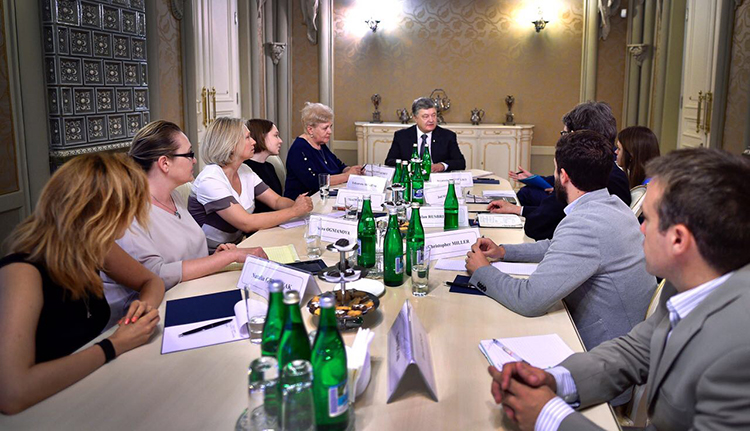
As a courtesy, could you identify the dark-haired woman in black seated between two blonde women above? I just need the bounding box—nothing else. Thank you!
[245,119,283,214]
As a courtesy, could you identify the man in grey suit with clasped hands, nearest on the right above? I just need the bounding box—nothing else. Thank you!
[489,149,750,430]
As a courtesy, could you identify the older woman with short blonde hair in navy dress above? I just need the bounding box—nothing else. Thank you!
[284,102,362,199]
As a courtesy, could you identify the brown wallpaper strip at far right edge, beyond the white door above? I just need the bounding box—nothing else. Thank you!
[724,1,750,154]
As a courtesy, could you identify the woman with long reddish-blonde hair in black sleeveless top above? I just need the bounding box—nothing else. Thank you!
[0,154,164,414]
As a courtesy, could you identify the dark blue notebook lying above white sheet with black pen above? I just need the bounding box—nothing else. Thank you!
[164,289,242,327]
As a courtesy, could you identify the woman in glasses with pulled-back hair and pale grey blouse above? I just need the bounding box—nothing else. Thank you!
[102,120,266,326]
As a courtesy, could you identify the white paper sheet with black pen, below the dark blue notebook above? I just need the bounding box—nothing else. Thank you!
[161,299,268,354]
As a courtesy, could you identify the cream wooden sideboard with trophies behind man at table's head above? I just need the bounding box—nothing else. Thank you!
[354,122,534,179]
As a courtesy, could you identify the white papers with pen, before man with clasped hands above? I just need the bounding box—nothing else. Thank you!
[479,334,573,370]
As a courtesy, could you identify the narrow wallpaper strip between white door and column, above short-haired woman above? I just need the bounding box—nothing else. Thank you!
[288,1,320,137]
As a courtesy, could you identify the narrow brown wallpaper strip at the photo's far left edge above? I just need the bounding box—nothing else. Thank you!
[0,2,18,195]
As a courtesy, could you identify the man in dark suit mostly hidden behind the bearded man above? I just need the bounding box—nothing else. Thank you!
[487,102,631,241]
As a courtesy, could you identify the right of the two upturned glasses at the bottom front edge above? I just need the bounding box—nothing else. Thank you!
[281,359,315,431]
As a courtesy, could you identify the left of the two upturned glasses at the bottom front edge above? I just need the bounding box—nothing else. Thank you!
[235,356,280,431]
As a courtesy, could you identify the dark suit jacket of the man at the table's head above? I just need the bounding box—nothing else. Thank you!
[385,124,466,171]
